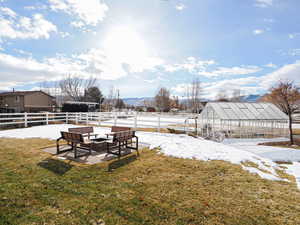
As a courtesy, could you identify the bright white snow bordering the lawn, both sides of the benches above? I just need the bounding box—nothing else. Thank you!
[0,124,288,184]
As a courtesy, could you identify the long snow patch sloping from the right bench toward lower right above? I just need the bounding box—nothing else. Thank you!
[138,132,280,179]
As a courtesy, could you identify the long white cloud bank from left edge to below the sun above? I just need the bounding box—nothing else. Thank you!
[0,45,163,89]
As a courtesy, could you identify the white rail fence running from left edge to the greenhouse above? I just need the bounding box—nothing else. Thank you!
[0,112,195,131]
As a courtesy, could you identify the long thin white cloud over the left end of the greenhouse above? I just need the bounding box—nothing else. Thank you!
[199,66,261,77]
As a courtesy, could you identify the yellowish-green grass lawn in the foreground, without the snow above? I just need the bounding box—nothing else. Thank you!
[0,139,300,225]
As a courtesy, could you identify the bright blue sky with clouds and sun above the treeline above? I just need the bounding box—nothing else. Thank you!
[0,0,300,99]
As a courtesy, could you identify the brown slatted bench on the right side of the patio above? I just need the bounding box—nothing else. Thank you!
[106,126,139,157]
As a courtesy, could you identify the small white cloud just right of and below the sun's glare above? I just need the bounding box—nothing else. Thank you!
[164,57,216,73]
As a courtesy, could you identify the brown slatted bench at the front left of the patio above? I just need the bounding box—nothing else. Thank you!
[56,131,93,158]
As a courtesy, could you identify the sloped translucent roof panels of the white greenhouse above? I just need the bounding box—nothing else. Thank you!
[201,102,288,120]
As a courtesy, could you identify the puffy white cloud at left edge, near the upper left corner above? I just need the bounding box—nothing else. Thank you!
[0,8,57,39]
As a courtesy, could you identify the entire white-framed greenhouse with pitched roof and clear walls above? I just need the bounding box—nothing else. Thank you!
[199,102,288,138]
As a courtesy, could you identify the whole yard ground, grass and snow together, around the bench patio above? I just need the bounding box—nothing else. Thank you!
[0,125,300,225]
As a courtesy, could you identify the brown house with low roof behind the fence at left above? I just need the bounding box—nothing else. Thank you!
[0,91,56,113]
